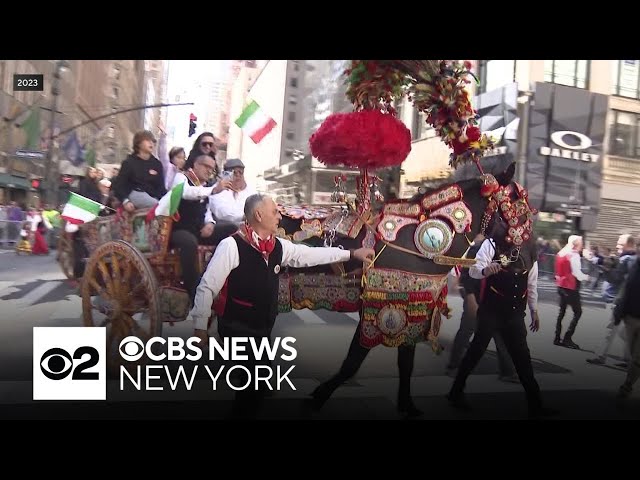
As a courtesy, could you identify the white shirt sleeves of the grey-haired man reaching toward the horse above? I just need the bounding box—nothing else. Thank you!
[187,237,351,330]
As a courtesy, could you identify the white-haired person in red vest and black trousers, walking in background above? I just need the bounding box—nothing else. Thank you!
[553,235,589,349]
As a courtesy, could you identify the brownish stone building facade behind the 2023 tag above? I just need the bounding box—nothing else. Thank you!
[0,60,144,206]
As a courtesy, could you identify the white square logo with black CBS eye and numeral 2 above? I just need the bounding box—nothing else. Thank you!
[33,327,107,400]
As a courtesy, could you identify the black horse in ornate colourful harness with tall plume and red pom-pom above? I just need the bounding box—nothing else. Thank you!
[264,60,531,416]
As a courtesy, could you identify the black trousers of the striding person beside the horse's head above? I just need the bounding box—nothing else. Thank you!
[450,305,542,410]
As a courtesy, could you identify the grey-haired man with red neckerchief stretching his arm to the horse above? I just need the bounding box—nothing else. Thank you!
[189,194,375,416]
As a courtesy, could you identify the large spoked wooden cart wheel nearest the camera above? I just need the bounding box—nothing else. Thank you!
[81,240,162,373]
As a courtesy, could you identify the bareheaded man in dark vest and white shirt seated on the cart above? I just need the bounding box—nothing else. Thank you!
[169,155,237,304]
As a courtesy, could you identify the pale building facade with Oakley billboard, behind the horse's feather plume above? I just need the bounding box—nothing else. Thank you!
[403,60,640,251]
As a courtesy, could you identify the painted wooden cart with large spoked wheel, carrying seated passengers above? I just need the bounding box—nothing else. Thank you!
[58,210,214,364]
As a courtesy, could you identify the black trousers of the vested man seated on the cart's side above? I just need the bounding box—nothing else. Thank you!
[169,222,238,304]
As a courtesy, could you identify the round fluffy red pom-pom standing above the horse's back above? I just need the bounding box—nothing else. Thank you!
[309,110,411,168]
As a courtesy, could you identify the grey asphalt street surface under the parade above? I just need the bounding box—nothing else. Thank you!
[0,250,640,420]
